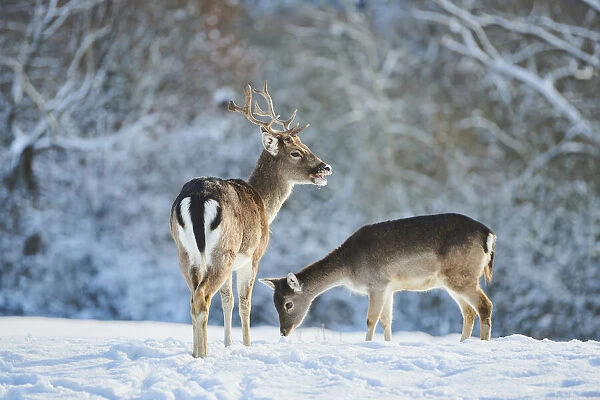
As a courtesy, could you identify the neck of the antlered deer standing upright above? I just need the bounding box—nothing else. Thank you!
[248,150,294,224]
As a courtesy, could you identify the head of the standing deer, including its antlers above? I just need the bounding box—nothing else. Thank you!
[228,81,332,186]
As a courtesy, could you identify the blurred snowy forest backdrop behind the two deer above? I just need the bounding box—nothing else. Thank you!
[0,0,600,340]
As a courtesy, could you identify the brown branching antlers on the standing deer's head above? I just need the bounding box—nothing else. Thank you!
[227,81,310,136]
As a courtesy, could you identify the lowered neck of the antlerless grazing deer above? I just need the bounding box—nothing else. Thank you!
[296,250,347,299]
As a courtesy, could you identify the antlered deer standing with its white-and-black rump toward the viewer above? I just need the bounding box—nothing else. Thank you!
[171,82,331,357]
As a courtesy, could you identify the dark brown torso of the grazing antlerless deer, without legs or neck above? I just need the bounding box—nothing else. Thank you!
[328,214,493,291]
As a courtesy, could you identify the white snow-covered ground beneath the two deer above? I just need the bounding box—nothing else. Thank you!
[0,317,600,399]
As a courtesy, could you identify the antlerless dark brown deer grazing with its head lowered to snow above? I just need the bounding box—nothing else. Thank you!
[260,214,496,341]
